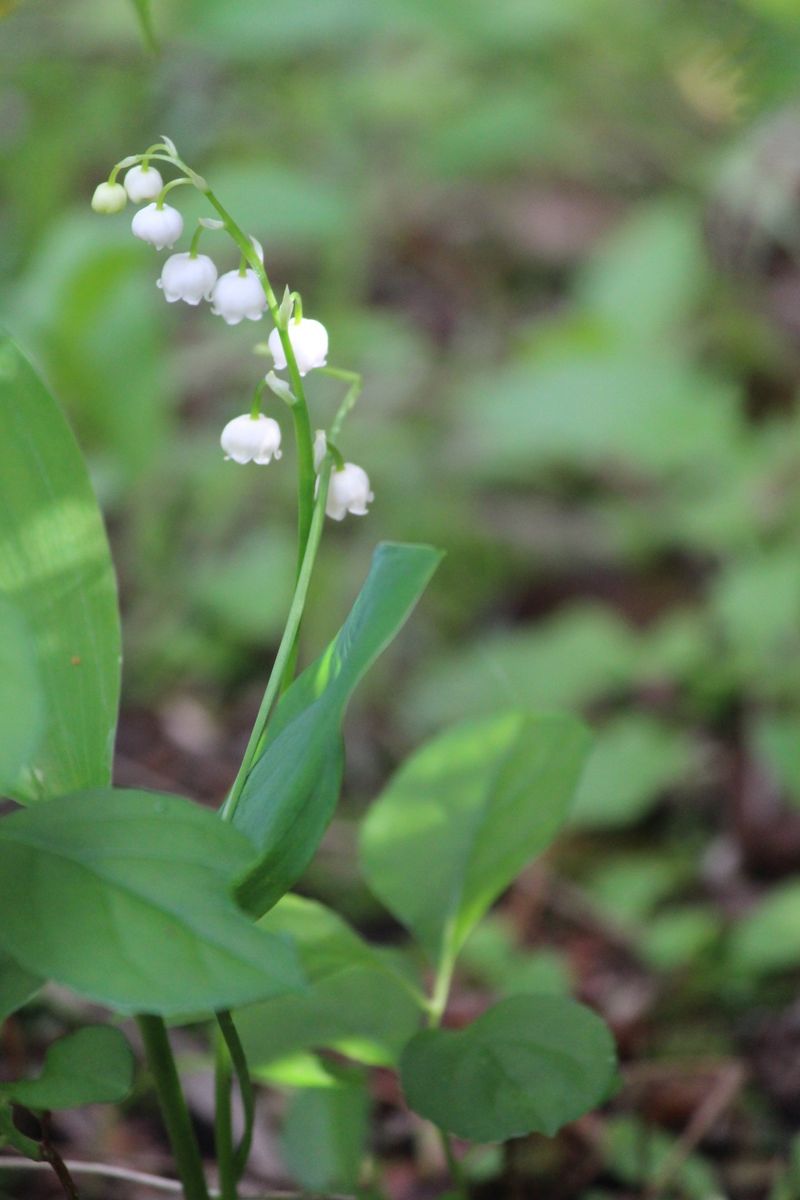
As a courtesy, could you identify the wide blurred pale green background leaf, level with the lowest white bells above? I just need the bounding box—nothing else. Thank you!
[456,346,742,485]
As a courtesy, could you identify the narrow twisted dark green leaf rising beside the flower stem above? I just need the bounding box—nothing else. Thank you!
[233,542,441,914]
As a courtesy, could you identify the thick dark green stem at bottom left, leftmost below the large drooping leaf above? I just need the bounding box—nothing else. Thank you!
[137,1014,209,1200]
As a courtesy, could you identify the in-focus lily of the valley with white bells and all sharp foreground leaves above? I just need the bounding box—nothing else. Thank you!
[0,138,614,1200]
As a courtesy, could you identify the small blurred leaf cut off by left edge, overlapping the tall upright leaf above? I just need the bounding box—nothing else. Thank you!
[0,596,44,794]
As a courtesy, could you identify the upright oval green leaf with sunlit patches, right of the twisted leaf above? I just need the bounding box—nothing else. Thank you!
[361,712,589,961]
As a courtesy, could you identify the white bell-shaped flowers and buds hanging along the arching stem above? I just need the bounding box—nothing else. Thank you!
[91,148,373,521]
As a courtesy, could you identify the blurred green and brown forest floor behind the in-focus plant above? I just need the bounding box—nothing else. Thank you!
[7,0,800,1200]
